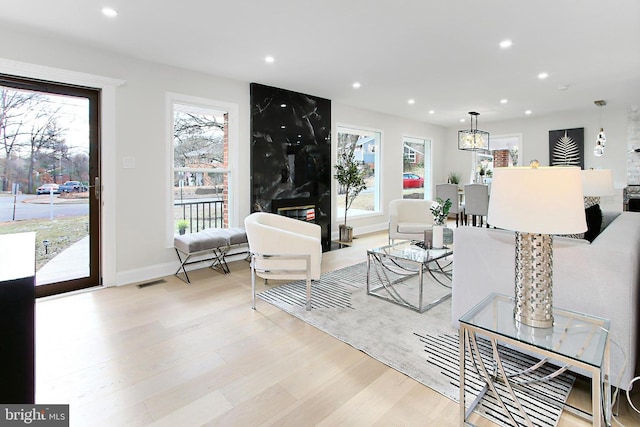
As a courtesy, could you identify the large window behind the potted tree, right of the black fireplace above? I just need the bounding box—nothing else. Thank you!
[337,125,382,218]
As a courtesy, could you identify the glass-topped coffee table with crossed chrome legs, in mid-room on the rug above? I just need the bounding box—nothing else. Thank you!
[367,241,453,313]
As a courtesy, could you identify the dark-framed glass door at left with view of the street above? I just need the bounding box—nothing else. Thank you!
[0,75,101,297]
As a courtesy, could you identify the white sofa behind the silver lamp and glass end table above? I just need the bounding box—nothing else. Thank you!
[451,212,640,390]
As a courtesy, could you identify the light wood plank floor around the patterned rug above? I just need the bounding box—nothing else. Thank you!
[36,233,640,427]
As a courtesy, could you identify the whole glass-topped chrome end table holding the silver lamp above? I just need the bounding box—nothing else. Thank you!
[460,294,611,426]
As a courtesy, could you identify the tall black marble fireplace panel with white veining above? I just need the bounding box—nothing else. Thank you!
[251,83,332,249]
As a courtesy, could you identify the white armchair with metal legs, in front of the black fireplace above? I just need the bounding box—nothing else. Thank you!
[244,212,322,310]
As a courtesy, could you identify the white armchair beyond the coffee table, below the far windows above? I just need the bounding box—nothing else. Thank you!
[389,199,434,243]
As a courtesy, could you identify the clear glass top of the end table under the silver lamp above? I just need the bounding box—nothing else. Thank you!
[460,293,609,367]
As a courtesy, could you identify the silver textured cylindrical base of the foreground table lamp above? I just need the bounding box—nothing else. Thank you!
[513,232,553,328]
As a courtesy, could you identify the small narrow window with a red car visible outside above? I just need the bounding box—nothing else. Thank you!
[402,136,431,199]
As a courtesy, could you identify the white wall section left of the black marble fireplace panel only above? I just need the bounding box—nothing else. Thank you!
[0,23,249,285]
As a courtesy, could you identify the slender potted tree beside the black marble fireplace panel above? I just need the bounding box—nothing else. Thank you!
[333,145,367,242]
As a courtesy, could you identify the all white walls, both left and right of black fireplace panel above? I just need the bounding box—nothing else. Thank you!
[7,26,628,285]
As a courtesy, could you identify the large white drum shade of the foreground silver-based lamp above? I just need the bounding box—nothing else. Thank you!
[487,166,587,234]
